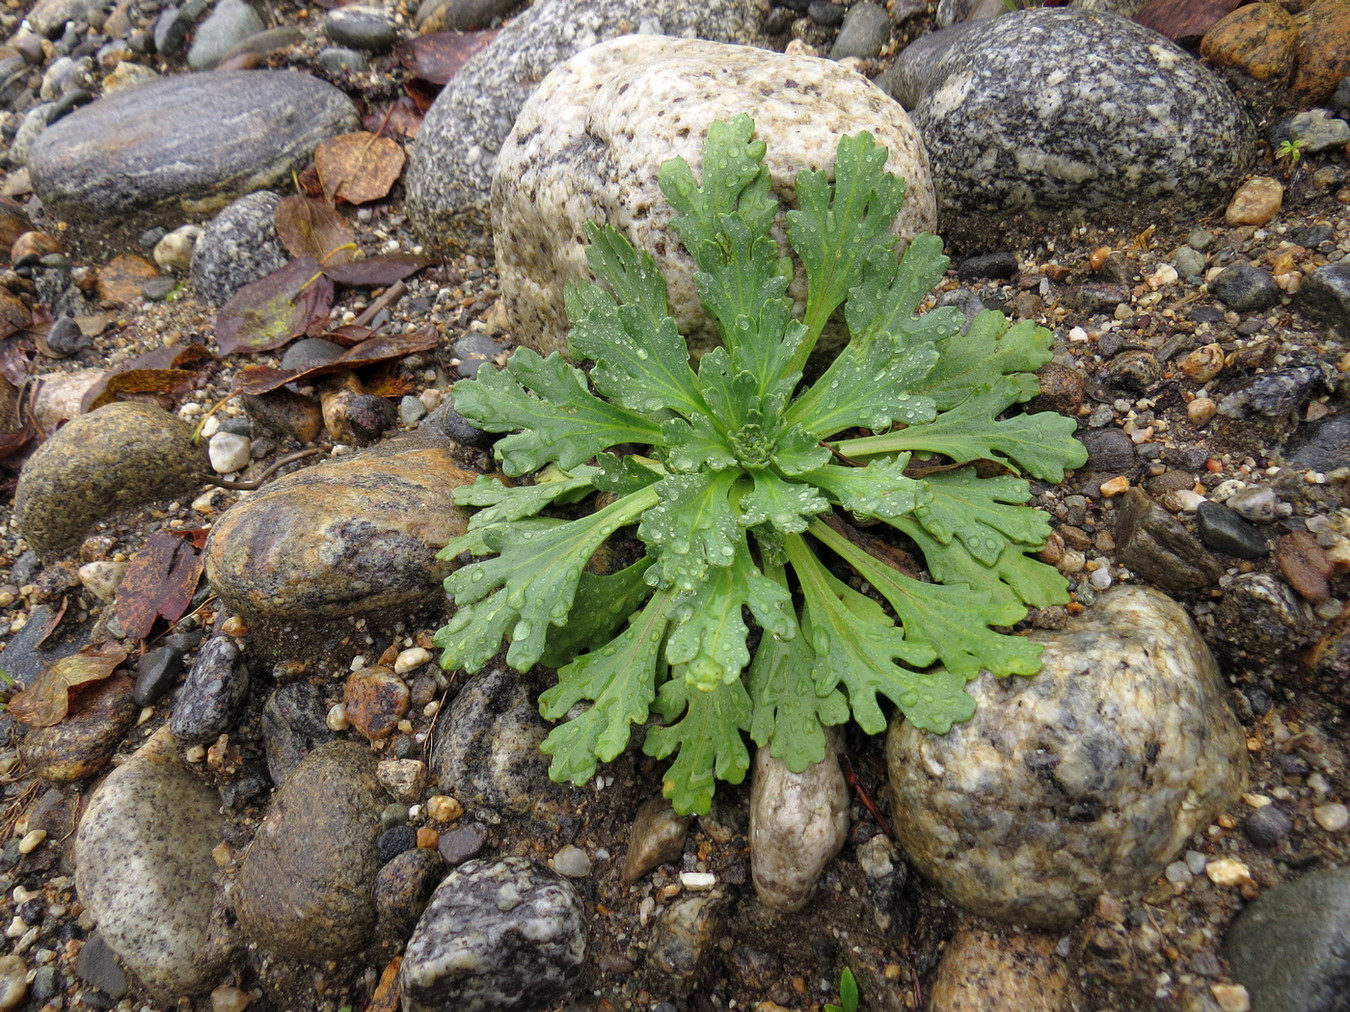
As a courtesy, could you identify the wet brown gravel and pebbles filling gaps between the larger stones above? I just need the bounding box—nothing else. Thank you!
[0,0,1350,1012]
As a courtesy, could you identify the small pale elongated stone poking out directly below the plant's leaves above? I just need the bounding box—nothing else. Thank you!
[751,727,849,912]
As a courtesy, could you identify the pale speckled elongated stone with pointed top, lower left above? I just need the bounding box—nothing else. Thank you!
[76,730,231,1004]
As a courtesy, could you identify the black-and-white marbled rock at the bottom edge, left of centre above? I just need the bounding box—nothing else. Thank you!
[398,857,586,1012]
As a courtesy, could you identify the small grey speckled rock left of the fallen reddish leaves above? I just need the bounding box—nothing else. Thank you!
[190,190,290,306]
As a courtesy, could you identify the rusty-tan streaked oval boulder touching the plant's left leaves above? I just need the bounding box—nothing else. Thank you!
[199,448,475,619]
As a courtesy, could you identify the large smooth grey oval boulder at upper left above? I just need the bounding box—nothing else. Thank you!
[28,70,356,225]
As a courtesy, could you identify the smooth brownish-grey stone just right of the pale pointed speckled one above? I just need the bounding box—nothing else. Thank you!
[235,741,383,961]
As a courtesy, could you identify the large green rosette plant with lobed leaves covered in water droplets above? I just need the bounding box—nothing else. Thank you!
[436,116,1087,814]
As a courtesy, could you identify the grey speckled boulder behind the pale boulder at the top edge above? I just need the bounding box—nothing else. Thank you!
[405,0,782,254]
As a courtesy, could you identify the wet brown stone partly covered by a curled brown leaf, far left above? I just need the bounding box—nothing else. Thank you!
[19,675,138,781]
